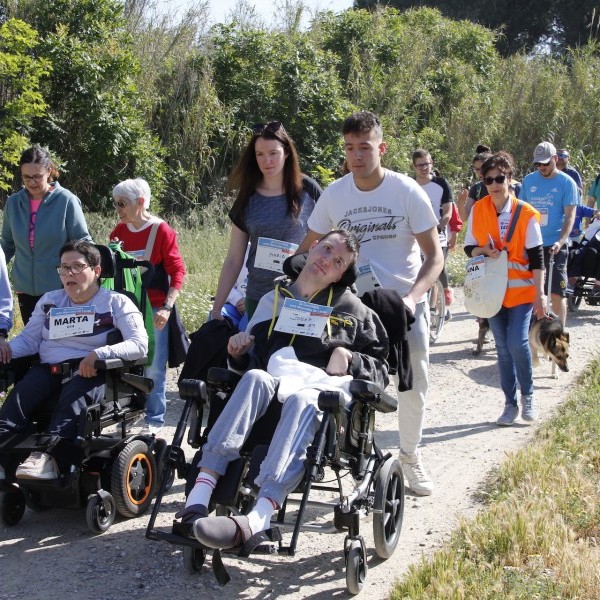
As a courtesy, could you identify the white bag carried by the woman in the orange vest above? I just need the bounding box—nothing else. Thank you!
[464,250,508,319]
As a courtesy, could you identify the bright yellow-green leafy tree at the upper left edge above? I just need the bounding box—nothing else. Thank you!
[0,19,50,192]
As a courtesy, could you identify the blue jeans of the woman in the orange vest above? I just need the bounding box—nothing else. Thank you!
[490,304,533,405]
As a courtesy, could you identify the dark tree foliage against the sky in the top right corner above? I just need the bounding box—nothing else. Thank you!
[354,0,598,55]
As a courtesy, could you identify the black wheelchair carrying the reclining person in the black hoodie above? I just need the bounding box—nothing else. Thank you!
[146,367,405,594]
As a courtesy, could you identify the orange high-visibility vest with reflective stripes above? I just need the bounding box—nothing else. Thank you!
[471,196,540,308]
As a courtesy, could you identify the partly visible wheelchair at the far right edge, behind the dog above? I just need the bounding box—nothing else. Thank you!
[567,236,600,312]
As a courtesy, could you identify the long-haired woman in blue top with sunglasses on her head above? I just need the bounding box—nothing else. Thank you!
[212,121,322,319]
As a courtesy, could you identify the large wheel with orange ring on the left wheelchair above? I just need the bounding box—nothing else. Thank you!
[111,440,157,517]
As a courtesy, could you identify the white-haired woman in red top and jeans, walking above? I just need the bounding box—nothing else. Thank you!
[110,179,185,433]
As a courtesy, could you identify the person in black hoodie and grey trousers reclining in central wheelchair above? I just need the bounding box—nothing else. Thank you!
[176,230,388,548]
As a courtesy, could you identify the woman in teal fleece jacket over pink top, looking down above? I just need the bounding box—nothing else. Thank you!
[0,146,92,324]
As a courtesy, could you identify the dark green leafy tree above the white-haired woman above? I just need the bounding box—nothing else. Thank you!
[11,0,164,209]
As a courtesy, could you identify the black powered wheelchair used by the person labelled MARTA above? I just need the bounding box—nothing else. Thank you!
[0,246,167,533]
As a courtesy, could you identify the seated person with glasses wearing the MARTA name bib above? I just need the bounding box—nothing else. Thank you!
[0,240,148,479]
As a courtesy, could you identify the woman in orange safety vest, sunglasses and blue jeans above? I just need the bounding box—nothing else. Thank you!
[465,152,546,426]
